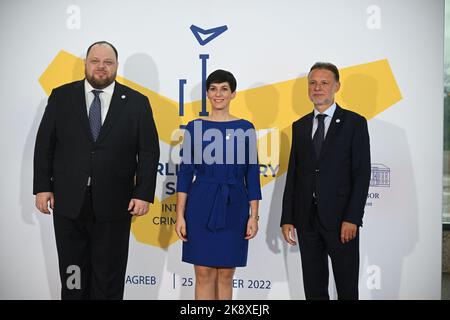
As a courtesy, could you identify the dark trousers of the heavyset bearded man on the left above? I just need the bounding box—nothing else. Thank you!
[53,187,131,300]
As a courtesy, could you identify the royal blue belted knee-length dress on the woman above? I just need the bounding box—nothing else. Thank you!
[177,119,261,268]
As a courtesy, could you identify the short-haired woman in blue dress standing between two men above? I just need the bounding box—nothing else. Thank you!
[175,70,261,299]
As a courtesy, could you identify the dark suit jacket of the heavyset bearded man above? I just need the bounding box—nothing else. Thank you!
[33,80,159,221]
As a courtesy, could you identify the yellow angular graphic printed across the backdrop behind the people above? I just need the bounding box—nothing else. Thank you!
[39,51,402,248]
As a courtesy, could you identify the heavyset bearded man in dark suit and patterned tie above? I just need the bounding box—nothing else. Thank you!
[33,41,159,299]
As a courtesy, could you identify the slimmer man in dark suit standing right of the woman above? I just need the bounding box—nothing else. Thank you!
[281,62,371,299]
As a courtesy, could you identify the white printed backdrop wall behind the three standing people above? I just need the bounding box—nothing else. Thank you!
[0,0,444,299]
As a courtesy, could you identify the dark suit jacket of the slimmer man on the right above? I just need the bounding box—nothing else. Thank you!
[281,106,371,230]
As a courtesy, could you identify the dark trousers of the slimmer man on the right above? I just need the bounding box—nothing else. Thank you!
[297,201,359,300]
